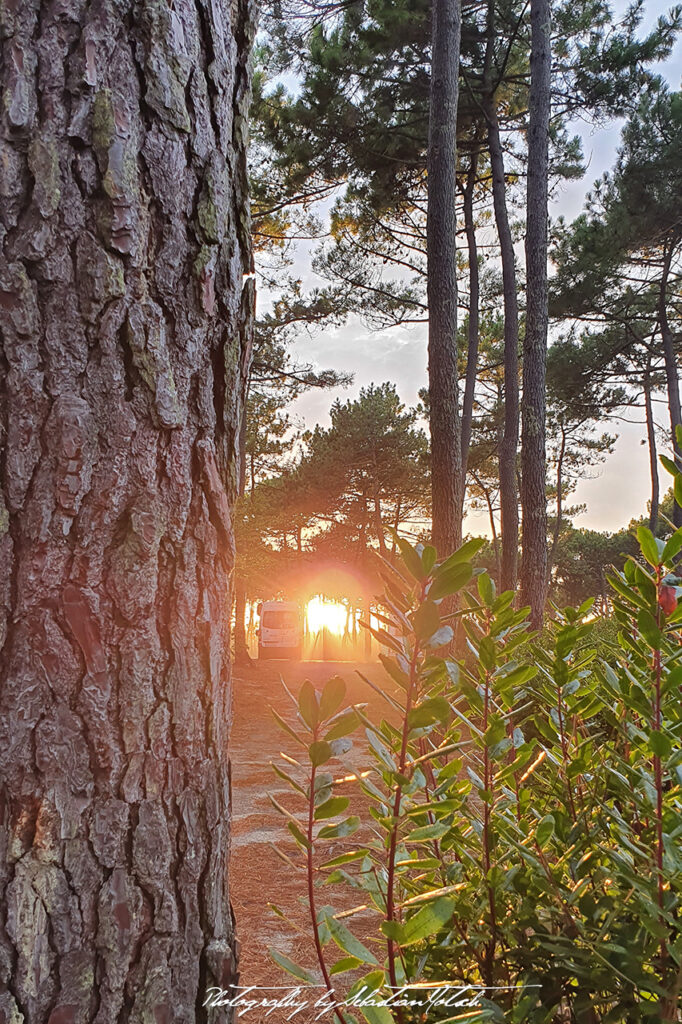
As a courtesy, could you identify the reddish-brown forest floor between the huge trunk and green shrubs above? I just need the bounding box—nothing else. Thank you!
[229,662,396,1024]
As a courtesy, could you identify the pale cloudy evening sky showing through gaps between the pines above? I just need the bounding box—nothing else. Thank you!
[266,0,682,532]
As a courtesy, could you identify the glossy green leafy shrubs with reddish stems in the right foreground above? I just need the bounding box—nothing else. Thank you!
[266,450,682,1024]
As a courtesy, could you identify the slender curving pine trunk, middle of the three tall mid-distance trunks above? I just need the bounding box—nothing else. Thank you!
[483,14,519,590]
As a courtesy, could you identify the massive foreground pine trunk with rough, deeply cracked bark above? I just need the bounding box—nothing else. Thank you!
[0,0,253,1024]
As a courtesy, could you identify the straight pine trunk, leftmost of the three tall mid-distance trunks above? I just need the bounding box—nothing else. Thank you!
[426,0,464,556]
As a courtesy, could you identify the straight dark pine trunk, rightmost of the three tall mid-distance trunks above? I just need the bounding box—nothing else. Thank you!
[521,0,552,629]
